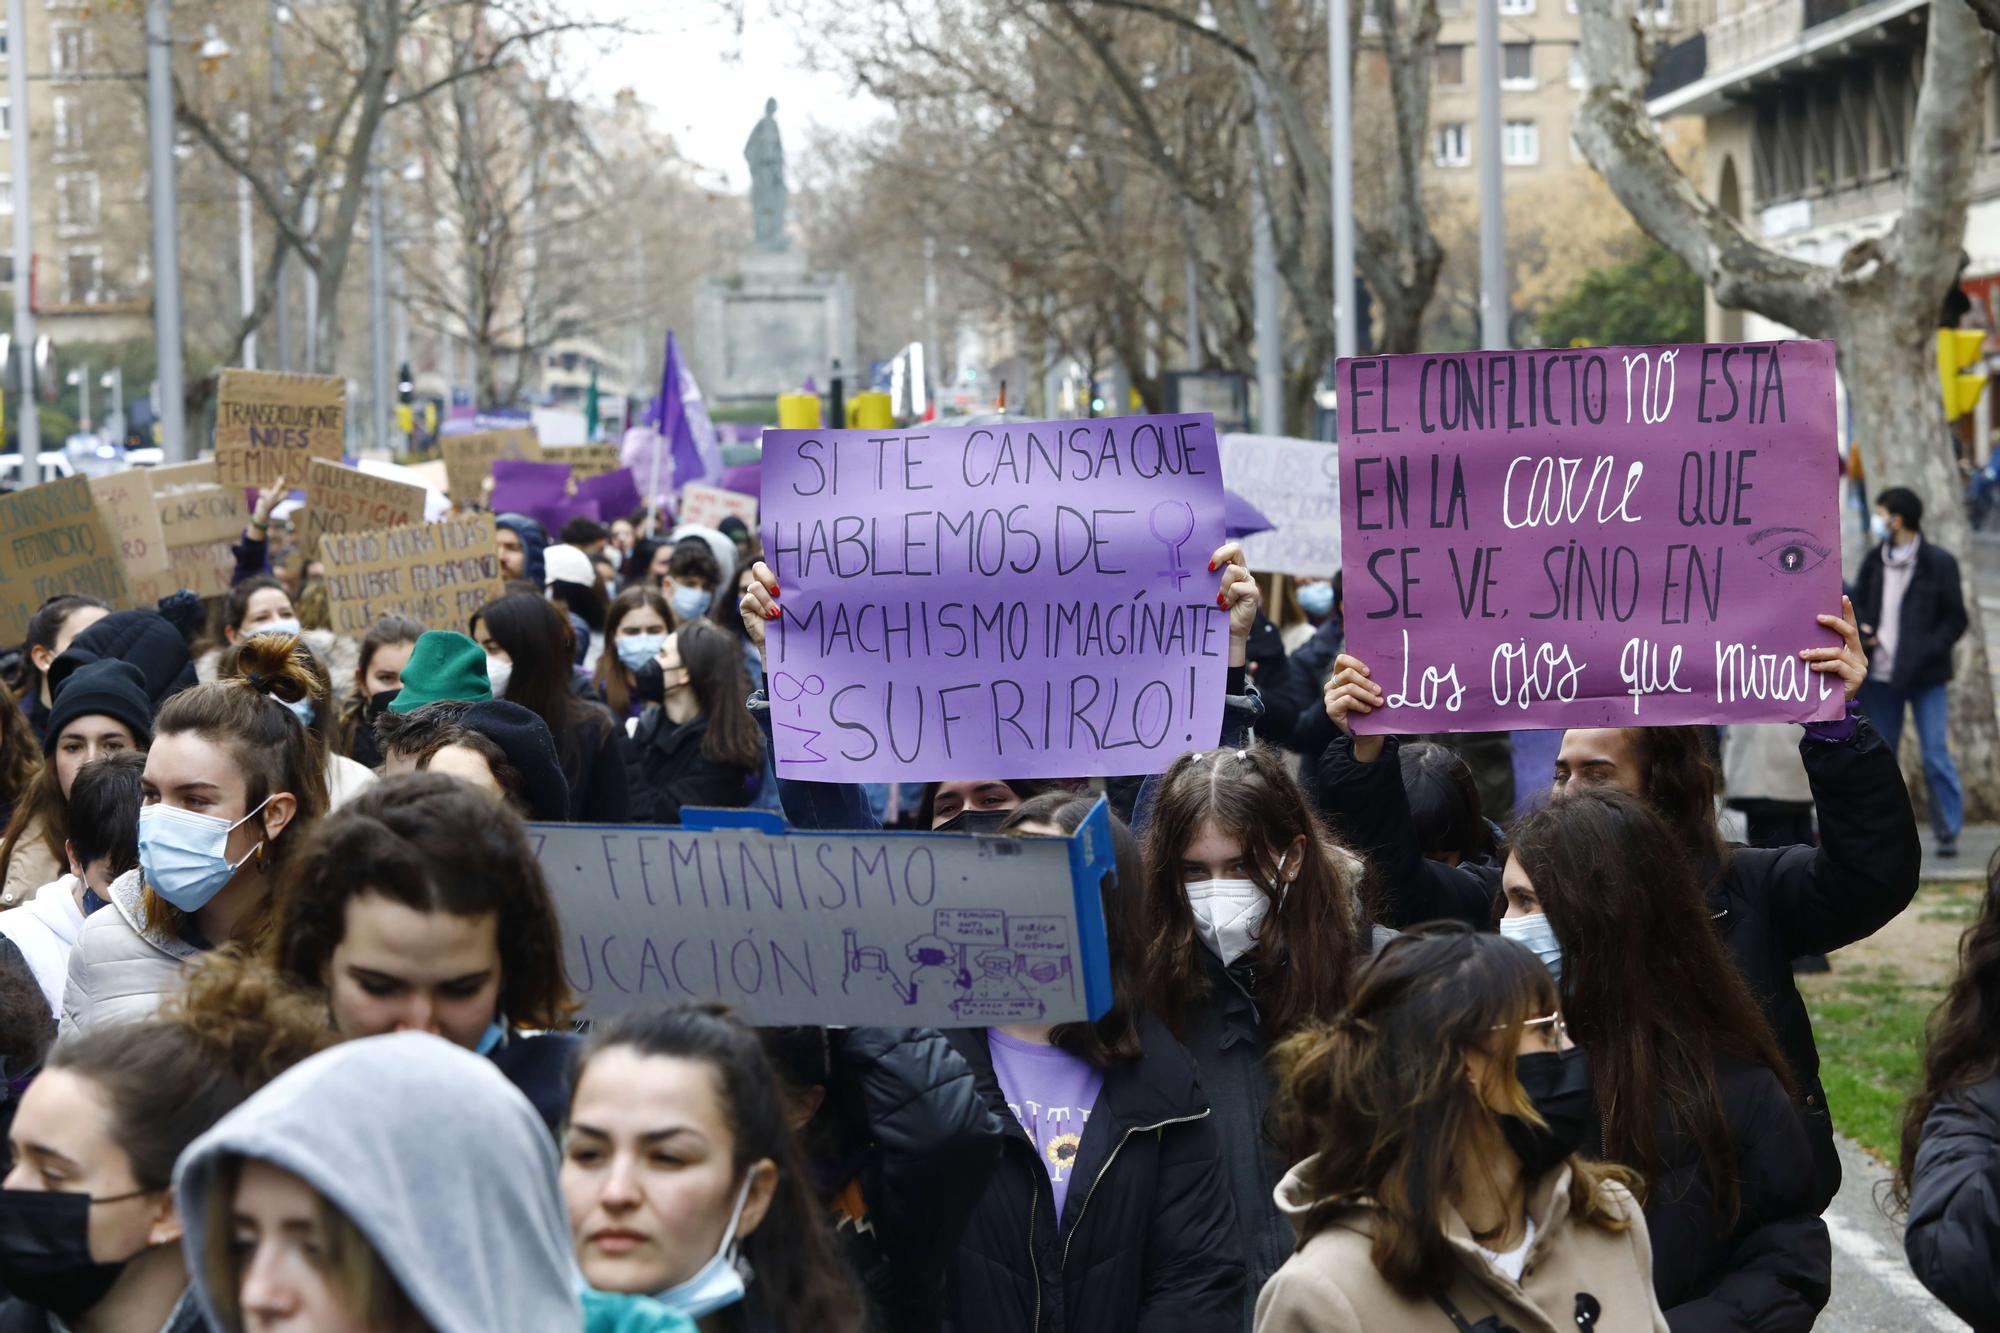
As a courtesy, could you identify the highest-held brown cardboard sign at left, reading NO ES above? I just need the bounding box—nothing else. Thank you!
[216,370,348,488]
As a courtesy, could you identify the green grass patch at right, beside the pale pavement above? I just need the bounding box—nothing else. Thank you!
[1800,959,1946,1161]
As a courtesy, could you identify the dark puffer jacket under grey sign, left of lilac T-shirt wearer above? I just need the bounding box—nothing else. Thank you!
[812,1027,1006,1333]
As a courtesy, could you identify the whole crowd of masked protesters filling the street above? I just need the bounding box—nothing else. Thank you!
[0,470,2000,1333]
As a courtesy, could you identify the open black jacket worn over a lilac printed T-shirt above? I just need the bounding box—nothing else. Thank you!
[948,1019,1244,1333]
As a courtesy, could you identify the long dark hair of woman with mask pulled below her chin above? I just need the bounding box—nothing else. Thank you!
[570,1005,862,1333]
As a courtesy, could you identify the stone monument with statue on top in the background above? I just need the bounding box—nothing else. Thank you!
[692,98,860,404]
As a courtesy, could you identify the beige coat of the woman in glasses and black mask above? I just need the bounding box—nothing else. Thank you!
[1256,1167,1666,1333]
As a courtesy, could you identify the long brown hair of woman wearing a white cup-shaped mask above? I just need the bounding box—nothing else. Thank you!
[1144,745,1362,1039]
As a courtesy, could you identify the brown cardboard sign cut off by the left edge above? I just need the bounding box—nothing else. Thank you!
[0,476,130,642]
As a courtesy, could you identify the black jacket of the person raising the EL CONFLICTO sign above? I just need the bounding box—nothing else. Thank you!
[1320,717,1922,1211]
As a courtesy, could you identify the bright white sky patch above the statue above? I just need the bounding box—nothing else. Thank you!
[590,0,880,192]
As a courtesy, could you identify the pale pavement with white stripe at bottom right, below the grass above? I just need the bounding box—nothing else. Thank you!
[1814,1139,1970,1333]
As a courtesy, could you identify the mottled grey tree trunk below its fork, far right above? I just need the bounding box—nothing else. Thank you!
[1840,306,2000,823]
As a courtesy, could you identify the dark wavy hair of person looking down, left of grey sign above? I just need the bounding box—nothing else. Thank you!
[272,773,576,1027]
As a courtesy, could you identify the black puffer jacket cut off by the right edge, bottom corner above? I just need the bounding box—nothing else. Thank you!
[1902,1079,2000,1333]
